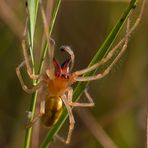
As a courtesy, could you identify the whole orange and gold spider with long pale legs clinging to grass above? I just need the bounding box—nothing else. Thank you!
[16,1,144,144]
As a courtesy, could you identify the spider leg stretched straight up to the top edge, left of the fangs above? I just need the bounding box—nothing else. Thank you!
[39,0,55,79]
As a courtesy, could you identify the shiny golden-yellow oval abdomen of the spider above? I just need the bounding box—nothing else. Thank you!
[41,97,63,127]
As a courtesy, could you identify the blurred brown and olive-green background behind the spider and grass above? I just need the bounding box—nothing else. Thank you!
[0,0,148,148]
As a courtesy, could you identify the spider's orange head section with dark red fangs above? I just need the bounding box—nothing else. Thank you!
[45,58,74,96]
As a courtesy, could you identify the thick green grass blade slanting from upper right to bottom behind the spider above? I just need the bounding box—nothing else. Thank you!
[41,0,136,148]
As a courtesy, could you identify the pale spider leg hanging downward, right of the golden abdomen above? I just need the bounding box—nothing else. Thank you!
[61,95,75,144]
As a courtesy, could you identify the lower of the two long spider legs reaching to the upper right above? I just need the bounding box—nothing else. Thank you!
[76,19,129,81]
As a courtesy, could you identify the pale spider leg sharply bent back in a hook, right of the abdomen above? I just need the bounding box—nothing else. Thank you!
[68,87,94,107]
